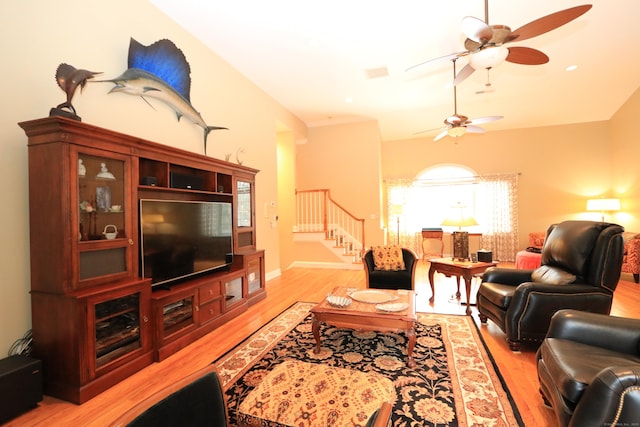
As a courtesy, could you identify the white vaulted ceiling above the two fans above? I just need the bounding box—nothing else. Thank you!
[150,0,640,140]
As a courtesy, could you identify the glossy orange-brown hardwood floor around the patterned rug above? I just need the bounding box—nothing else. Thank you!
[6,262,640,427]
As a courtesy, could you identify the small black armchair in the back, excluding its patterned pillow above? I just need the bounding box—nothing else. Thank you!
[362,248,418,290]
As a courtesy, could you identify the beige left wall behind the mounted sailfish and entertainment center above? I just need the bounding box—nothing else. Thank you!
[0,0,306,354]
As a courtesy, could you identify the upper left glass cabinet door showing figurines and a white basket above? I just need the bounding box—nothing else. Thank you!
[75,152,133,287]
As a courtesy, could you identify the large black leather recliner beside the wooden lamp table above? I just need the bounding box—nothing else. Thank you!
[477,221,624,351]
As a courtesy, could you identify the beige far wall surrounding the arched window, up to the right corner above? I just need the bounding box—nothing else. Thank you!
[382,117,611,247]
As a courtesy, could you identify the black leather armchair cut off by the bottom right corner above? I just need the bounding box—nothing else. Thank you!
[537,310,640,427]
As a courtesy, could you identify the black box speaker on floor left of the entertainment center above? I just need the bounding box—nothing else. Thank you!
[0,355,42,424]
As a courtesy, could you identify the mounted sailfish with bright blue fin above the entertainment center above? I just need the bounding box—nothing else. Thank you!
[95,38,227,154]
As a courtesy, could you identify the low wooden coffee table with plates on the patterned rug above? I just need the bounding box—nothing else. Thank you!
[311,287,417,368]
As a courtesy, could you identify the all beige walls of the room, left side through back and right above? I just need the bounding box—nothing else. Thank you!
[0,0,640,362]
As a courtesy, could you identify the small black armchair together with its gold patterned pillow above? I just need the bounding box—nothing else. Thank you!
[362,246,418,290]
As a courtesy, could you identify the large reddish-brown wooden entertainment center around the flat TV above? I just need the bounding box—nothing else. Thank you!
[19,117,266,404]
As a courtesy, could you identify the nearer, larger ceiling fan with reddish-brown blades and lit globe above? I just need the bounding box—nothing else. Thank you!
[407,0,592,85]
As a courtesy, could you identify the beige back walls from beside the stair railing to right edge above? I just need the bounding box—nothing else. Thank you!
[296,89,640,254]
